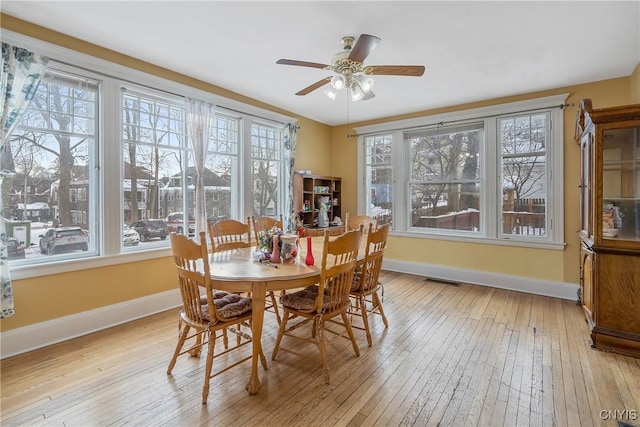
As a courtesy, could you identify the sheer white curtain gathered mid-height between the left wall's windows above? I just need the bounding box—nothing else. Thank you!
[185,98,215,236]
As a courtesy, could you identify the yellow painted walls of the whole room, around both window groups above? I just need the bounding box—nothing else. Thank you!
[0,14,640,331]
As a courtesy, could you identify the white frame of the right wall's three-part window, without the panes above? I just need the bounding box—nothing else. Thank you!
[355,93,569,250]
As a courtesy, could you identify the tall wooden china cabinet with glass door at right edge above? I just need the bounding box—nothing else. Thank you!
[576,99,640,357]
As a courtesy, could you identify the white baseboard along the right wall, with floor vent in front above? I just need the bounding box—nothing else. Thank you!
[382,258,580,301]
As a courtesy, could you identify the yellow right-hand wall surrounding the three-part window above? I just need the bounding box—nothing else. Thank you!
[332,79,639,284]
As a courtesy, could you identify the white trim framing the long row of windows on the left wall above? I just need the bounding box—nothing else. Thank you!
[0,28,297,280]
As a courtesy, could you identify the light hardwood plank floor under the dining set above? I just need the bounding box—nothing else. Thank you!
[0,272,640,426]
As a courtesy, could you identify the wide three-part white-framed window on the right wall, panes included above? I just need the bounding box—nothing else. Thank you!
[356,95,566,248]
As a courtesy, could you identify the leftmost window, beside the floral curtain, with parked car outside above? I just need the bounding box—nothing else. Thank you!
[7,67,101,263]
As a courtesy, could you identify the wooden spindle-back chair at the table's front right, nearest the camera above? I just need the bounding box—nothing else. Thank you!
[271,229,363,383]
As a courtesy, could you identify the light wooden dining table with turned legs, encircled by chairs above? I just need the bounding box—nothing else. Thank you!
[209,236,366,394]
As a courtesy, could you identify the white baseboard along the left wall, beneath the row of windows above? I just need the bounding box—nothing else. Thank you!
[0,288,182,359]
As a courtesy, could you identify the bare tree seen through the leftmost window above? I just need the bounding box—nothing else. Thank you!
[11,75,97,232]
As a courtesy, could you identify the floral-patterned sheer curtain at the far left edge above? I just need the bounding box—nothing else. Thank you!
[0,43,49,319]
